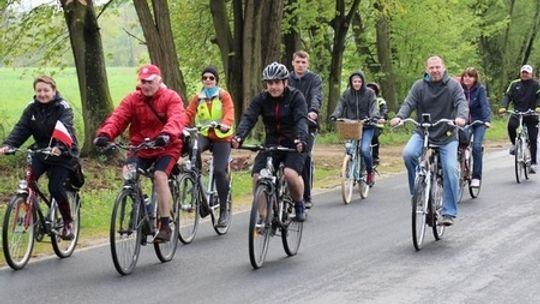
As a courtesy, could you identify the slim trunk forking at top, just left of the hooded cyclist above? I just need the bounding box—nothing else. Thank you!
[326,0,360,127]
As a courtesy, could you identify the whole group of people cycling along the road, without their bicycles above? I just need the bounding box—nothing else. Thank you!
[0,51,540,264]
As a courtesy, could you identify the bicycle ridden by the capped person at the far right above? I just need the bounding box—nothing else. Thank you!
[507,109,538,184]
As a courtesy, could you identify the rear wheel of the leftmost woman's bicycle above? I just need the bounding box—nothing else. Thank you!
[51,191,81,258]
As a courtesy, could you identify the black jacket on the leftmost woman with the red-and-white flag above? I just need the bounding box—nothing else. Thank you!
[3,93,79,163]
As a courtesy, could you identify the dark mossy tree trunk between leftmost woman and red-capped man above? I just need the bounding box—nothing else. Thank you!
[60,0,113,156]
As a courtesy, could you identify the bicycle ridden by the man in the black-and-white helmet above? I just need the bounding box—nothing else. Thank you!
[239,145,304,269]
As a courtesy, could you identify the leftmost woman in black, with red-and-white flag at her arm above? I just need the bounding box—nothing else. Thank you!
[0,75,79,240]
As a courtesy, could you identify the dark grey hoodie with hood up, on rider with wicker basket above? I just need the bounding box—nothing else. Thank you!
[330,71,378,119]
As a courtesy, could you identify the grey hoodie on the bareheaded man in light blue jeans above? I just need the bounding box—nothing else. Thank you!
[396,71,469,145]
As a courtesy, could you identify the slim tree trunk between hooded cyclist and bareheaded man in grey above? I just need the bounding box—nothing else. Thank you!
[375,2,399,111]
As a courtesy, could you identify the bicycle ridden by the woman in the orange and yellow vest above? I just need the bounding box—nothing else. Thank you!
[178,122,232,244]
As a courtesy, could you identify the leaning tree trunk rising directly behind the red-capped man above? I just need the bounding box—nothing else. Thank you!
[133,0,187,103]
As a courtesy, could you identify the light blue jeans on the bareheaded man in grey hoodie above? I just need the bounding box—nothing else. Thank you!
[403,133,459,217]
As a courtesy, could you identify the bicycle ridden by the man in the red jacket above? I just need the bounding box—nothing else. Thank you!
[105,139,179,275]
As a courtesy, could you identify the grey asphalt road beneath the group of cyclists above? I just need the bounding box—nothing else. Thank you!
[0,151,540,304]
